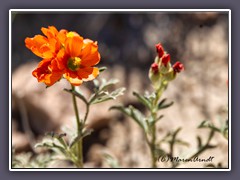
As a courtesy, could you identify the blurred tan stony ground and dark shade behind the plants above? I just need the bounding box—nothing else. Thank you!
[11,12,229,168]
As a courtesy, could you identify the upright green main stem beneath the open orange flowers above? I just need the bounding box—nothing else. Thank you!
[72,85,83,168]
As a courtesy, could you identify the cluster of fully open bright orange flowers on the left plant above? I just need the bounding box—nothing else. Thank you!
[25,26,100,86]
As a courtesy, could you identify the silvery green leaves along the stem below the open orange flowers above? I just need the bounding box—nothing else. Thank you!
[35,76,125,165]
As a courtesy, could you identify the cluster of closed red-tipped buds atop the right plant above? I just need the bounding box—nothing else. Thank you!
[149,43,184,89]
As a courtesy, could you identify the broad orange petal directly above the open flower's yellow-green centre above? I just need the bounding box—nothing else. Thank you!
[65,36,83,57]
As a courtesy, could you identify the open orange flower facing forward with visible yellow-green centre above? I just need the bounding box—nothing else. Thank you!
[59,32,100,86]
